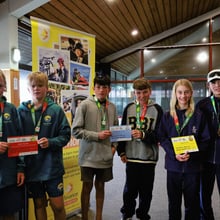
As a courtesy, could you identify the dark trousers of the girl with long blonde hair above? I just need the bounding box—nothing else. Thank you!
[167,171,200,220]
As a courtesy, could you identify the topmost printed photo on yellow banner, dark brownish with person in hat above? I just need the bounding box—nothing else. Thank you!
[60,35,89,65]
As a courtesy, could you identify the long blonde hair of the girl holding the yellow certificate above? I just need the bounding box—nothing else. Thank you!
[170,79,195,117]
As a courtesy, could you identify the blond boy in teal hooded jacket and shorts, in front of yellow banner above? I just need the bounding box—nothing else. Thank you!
[18,72,71,220]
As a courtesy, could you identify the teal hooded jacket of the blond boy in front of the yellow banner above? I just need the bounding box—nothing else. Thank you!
[18,99,71,182]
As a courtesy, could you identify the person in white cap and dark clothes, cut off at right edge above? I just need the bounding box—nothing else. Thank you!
[197,69,220,220]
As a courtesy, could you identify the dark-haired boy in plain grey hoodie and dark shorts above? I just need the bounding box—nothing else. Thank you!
[72,75,118,220]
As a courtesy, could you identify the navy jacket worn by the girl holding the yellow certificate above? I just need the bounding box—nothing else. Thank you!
[158,109,210,173]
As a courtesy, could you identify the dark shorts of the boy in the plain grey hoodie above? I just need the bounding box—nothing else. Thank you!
[80,167,113,182]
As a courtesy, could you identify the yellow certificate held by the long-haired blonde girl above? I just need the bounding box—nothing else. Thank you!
[171,135,199,155]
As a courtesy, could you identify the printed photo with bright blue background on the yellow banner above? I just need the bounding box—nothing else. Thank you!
[70,62,91,90]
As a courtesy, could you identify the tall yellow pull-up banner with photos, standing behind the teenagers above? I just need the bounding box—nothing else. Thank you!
[28,17,95,220]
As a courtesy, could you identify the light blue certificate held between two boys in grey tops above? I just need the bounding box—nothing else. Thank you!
[110,125,131,142]
